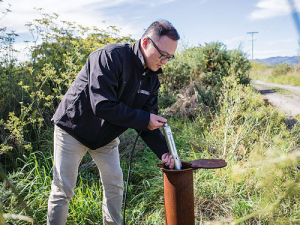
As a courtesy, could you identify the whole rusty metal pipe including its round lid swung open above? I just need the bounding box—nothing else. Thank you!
[158,159,227,225]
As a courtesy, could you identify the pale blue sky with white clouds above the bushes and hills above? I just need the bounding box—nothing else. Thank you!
[0,0,300,59]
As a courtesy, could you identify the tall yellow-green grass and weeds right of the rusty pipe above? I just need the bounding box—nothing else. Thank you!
[176,78,300,224]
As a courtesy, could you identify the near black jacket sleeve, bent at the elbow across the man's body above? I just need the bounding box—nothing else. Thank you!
[87,50,150,131]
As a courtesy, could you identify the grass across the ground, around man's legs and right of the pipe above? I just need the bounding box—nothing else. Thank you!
[0,78,300,224]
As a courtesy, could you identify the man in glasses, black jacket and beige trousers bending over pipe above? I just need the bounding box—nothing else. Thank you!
[47,20,180,225]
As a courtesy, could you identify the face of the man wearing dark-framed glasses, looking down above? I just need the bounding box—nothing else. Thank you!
[141,35,177,71]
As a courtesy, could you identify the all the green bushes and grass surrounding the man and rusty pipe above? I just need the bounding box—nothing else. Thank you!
[0,11,300,224]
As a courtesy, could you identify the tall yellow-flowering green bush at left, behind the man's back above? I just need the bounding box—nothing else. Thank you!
[0,14,133,170]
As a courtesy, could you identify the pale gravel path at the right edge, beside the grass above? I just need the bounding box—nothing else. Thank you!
[251,80,300,119]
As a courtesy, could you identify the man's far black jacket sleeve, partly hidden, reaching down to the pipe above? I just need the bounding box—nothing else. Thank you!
[141,74,169,160]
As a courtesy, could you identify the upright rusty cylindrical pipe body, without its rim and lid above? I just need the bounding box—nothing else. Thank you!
[163,168,195,225]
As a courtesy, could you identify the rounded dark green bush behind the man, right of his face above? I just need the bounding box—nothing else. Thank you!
[160,42,251,115]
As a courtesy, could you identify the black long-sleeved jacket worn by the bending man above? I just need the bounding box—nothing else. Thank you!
[53,41,168,158]
